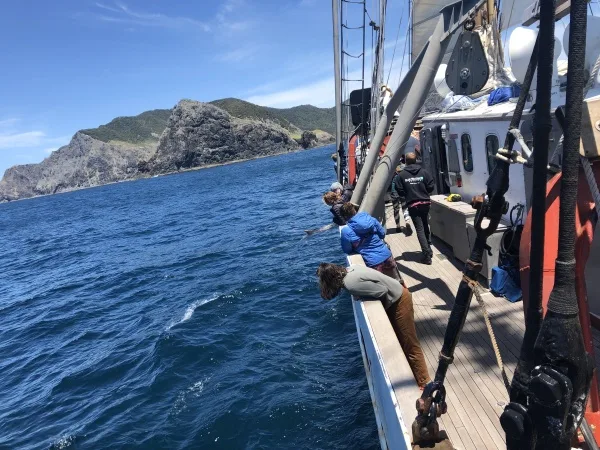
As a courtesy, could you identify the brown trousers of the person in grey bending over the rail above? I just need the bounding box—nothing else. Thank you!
[386,288,431,387]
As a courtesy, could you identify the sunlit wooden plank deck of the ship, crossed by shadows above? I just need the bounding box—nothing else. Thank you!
[386,210,525,450]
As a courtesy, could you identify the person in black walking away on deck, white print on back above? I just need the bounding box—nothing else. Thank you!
[394,152,434,264]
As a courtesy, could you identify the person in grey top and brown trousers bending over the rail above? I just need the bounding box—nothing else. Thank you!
[317,263,431,389]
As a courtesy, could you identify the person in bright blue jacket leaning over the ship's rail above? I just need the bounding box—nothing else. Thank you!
[340,202,404,284]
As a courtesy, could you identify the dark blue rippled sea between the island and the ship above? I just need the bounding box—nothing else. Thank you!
[0,147,378,449]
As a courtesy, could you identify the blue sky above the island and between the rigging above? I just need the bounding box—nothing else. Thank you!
[0,0,407,174]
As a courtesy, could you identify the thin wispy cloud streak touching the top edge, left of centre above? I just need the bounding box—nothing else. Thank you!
[96,3,211,32]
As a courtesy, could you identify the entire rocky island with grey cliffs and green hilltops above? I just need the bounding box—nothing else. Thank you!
[0,99,334,202]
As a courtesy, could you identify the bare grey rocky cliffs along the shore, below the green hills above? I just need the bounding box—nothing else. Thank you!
[0,100,300,202]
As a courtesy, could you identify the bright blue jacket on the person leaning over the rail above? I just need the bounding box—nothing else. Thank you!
[342,212,392,267]
